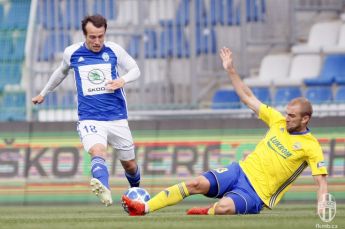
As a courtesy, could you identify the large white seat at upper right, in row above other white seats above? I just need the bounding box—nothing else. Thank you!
[292,21,341,54]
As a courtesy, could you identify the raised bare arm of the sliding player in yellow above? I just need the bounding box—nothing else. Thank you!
[219,47,261,114]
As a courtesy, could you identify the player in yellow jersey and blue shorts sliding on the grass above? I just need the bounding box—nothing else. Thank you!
[122,48,327,216]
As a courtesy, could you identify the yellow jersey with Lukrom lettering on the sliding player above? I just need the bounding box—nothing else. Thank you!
[239,104,327,208]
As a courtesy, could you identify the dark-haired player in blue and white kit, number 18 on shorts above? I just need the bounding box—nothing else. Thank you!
[32,15,140,206]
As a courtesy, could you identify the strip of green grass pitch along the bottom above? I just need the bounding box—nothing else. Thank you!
[0,203,345,229]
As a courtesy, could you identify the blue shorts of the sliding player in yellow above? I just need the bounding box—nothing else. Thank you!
[203,162,264,214]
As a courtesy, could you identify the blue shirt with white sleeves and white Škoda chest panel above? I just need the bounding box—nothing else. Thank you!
[62,42,137,121]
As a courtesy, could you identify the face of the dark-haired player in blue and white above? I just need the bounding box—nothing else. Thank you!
[85,22,105,52]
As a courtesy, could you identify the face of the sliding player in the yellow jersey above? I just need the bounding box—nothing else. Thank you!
[286,104,306,133]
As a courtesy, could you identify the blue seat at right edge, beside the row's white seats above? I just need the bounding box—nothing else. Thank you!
[304,55,345,86]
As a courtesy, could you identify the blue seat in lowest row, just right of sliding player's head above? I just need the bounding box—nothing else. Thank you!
[305,86,333,104]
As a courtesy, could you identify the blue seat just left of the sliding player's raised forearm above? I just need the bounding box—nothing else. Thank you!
[211,89,241,109]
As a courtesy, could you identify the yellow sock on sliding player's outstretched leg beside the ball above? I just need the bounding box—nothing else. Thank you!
[147,182,189,212]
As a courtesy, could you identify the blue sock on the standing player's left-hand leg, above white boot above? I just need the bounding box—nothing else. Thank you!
[91,157,109,189]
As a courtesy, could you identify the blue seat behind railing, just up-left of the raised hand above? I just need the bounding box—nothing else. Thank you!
[195,26,217,55]
